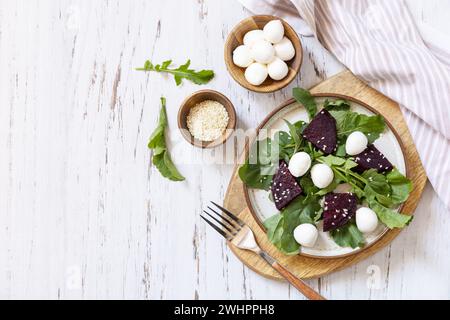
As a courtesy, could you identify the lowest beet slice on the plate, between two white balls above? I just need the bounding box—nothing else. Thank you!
[323,193,357,232]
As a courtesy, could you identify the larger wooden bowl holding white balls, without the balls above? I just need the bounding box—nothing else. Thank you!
[225,15,303,93]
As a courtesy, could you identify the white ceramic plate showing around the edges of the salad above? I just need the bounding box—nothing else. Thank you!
[246,94,406,258]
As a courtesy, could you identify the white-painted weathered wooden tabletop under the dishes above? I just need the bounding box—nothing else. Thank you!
[0,0,450,299]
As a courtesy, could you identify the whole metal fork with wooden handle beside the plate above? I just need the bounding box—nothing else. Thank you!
[201,201,325,300]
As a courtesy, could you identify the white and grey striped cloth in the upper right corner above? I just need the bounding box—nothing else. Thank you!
[240,0,450,208]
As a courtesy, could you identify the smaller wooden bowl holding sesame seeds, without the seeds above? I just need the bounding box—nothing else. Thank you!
[178,90,236,148]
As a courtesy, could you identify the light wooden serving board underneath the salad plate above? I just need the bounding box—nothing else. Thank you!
[224,71,427,280]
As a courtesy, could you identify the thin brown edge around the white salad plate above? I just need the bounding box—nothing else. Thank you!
[242,93,411,260]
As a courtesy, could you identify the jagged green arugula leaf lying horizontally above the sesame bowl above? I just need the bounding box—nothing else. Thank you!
[136,60,214,86]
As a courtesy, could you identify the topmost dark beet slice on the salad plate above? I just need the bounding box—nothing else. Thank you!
[303,109,337,155]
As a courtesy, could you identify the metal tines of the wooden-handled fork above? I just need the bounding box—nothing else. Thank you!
[201,201,245,241]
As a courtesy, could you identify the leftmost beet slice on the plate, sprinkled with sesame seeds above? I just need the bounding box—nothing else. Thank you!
[271,161,302,211]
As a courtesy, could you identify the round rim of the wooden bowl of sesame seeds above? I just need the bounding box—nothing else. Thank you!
[177,89,237,149]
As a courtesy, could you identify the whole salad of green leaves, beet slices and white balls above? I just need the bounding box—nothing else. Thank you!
[239,88,412,255]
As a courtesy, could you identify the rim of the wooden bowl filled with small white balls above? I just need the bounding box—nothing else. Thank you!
[224,15,303,93]
